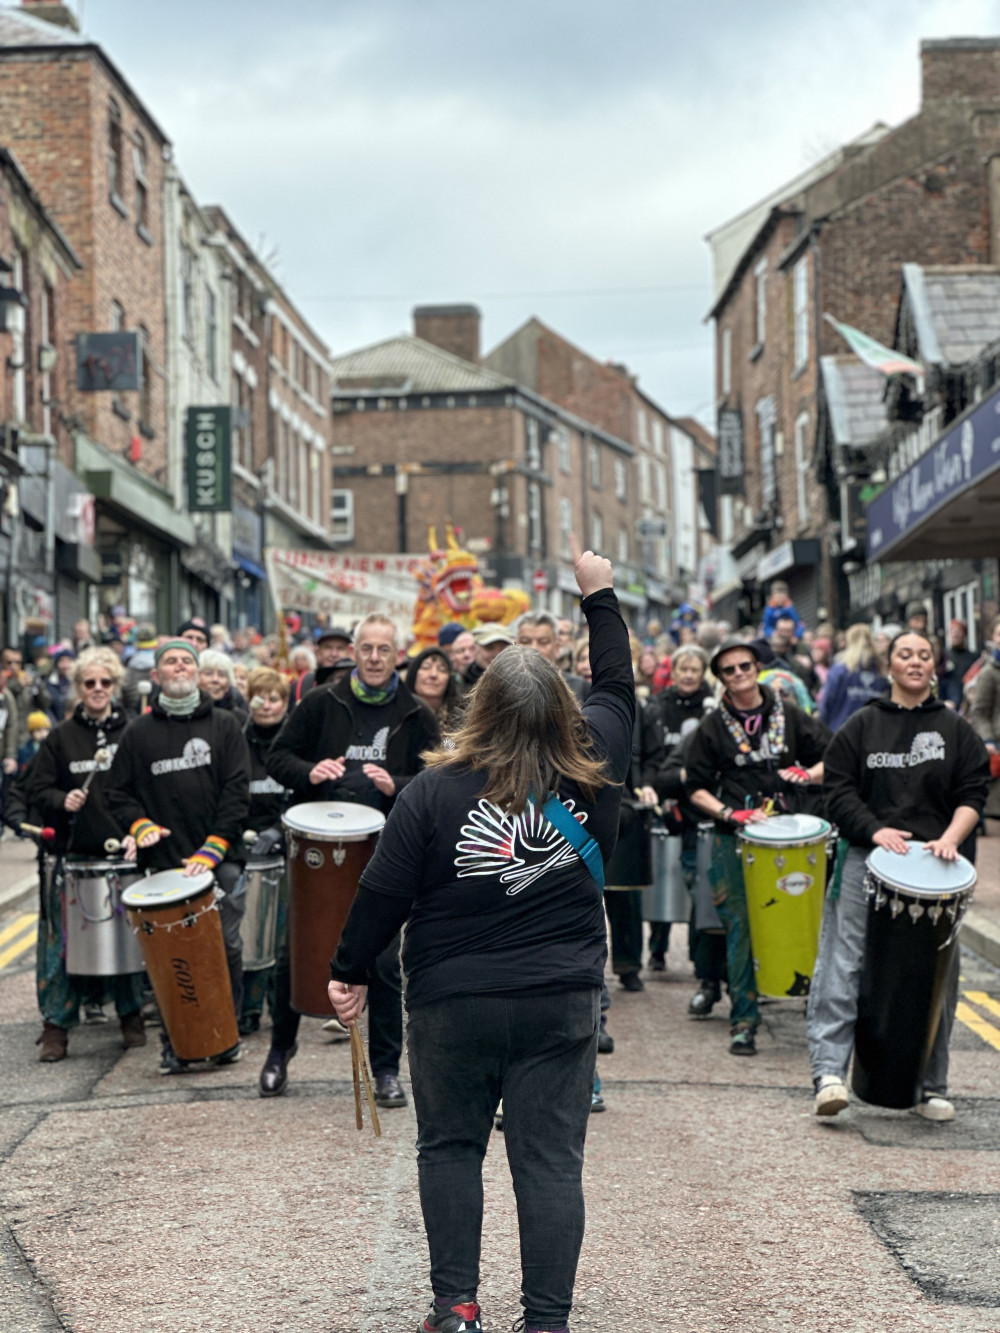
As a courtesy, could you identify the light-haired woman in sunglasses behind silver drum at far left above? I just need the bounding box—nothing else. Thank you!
[27,648,145,1064]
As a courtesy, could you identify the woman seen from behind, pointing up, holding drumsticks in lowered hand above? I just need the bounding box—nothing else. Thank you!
[329,541,635,1333]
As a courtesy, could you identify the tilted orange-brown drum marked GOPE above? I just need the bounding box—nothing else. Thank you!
[121,870,240,1060]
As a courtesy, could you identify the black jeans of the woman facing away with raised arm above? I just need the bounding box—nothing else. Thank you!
[407,989,600,1328]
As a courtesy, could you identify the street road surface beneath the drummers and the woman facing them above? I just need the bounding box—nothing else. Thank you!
[0,825,1000,1333]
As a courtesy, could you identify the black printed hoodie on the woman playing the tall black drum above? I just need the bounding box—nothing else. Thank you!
[823,698,989,846]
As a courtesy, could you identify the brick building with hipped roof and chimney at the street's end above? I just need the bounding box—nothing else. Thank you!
[332,307,645,615]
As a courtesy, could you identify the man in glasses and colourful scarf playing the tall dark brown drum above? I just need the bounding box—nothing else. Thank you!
[260,615,439,1108]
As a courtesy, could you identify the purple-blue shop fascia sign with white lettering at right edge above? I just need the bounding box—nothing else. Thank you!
[868,392,1000,560]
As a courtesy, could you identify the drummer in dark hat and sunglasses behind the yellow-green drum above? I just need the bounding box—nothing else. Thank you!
[687,639,829,1056]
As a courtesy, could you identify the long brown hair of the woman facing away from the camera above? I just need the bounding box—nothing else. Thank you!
[424,647,611,814]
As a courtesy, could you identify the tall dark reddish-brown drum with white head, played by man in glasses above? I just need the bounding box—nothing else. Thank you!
[283,801,385,1018]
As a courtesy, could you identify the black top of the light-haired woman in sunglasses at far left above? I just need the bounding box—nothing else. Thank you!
[27,704,128,856]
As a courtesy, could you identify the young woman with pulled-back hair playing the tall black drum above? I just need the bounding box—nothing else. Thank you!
[807,629,989,1120]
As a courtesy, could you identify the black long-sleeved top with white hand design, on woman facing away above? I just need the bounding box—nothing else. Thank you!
[331,589,636,1006]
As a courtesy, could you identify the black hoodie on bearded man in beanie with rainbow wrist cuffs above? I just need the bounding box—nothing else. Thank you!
[108,690,249,870]
